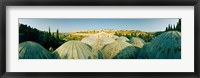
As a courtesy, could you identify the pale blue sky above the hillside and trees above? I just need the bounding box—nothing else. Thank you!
[19,18,178,32]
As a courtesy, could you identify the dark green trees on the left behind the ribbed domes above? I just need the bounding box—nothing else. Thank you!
[19,24,65,51]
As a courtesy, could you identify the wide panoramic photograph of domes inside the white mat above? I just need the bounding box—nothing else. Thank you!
[18,18,181,59]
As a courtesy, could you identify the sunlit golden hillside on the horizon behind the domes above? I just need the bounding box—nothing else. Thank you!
[60,29,163,42]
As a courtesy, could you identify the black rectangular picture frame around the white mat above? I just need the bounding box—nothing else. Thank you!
[0,0,200,78]
